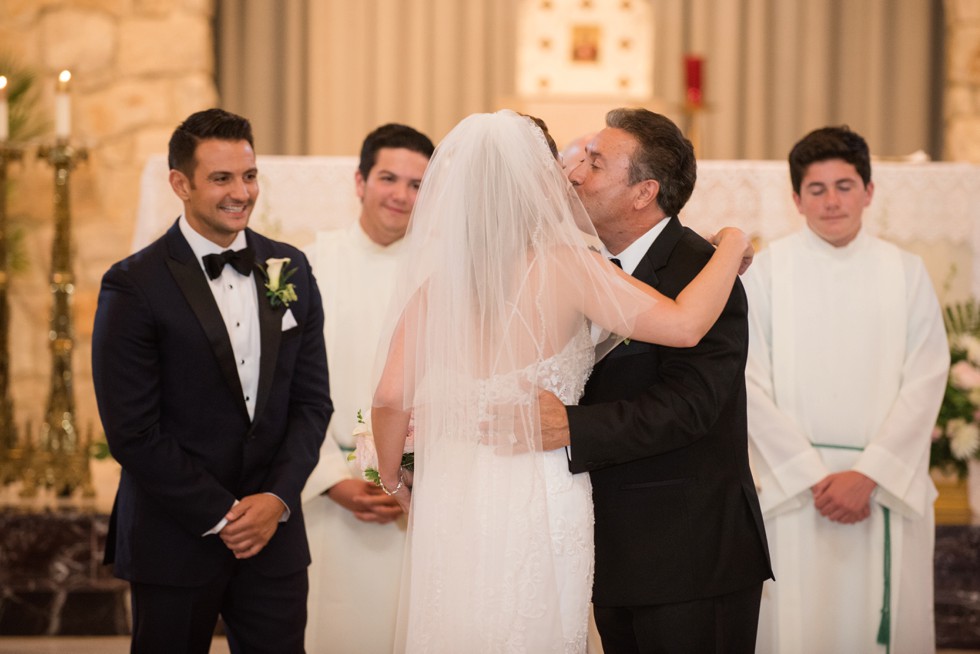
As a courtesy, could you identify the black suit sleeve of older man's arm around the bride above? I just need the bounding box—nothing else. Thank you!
[567,262,748,472]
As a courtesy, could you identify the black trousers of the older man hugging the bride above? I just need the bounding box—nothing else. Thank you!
[593,583,762,654]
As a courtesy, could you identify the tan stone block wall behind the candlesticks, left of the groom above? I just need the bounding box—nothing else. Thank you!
[0,0,218,464]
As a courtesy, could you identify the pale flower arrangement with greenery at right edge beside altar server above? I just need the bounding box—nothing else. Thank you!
[929,300,980,479]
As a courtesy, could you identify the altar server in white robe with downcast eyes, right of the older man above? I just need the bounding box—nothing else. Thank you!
[743,127,949,654]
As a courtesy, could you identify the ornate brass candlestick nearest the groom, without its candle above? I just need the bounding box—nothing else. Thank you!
[23,138,91,497]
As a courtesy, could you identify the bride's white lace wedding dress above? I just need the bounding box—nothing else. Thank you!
[403,326,594,654]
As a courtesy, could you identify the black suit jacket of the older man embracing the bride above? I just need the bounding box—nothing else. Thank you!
[568,218,772,606]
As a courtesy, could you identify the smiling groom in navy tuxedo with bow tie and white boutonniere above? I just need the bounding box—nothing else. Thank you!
[92,109,333,654]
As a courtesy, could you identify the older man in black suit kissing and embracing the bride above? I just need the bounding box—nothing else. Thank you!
[542,109,772,654]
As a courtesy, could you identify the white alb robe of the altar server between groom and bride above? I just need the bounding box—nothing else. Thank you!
[303,222,407,654]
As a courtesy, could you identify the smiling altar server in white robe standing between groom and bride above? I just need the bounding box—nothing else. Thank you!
[303,124,434,654]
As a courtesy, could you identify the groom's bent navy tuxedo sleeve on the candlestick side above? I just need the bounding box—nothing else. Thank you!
[92,266,235,535]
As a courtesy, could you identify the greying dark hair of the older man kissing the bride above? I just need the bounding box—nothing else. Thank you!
[606,108,698,216]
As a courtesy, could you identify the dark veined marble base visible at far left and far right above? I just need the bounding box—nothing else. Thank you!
[0,507,980,651]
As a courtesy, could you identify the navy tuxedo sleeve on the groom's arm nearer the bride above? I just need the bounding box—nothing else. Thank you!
[263,254,333,512]
